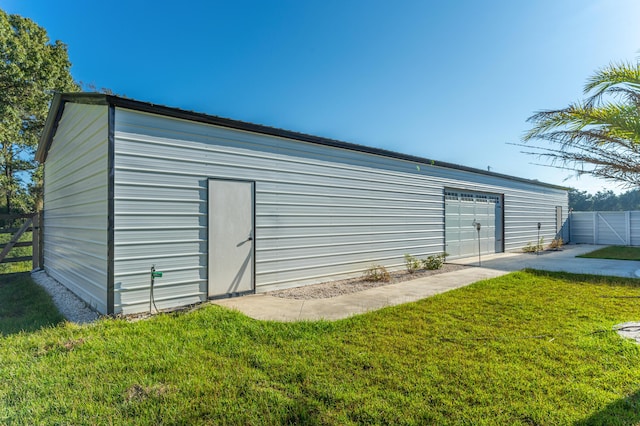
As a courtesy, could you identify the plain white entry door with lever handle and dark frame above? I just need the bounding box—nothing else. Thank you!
[209,179,254,297]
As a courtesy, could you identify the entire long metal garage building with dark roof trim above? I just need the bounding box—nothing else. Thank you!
[36,93,568,314]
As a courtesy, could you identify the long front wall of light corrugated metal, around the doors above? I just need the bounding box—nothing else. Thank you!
[114,109,567,312]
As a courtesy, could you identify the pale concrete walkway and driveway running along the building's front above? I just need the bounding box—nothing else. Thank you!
[212,245,640,321]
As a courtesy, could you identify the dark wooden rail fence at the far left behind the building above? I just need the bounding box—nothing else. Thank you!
[0,213,42,269]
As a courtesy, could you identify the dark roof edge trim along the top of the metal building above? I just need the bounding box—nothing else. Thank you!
[36,93,569,191]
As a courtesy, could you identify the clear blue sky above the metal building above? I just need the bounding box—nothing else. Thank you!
[0,0,640,193]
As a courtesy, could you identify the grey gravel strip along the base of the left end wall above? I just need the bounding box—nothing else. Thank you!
[31,270,100,324]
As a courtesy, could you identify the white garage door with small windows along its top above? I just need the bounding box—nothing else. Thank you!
[445,190,503,258]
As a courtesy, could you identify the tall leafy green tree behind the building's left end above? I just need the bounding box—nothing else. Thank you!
[0,10,79,211]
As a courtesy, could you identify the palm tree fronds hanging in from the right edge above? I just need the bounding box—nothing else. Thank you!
[523,62,640,186]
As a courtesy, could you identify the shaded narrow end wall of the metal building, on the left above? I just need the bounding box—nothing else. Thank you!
[44,104,108,313]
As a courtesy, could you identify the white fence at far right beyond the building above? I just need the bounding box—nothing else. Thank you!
[569,211,640,246]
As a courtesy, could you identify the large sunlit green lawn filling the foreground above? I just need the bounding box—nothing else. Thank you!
[0,271,640,425]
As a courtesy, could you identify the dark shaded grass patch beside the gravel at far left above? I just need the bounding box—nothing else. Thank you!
[0,272,64,336]
